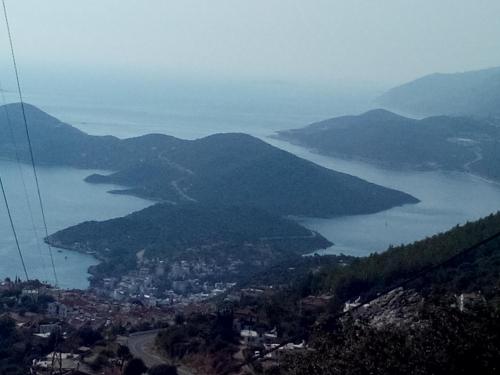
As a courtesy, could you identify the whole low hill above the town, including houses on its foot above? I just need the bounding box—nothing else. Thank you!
[47,203,331,282]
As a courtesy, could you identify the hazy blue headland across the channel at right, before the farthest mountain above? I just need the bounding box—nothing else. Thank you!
[277,109,500,179]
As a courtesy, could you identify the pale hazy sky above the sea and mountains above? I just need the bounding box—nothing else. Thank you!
[0,0,500,84]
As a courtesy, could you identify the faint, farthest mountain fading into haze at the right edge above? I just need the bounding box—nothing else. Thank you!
[377,67,500,117]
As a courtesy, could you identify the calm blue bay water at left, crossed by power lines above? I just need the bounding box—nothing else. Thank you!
[0,161,150,289]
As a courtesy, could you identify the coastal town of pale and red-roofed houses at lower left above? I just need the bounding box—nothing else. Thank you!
[0,269,318,375]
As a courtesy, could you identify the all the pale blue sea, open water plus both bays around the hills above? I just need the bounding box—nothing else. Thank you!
[0,83,500,288]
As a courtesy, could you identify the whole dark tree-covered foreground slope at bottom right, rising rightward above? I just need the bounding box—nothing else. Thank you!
[233,213,500,375]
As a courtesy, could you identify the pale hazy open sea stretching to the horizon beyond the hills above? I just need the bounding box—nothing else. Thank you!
[0,62,494,139]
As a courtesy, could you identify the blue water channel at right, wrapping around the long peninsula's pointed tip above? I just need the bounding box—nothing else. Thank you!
[268,139,500,256]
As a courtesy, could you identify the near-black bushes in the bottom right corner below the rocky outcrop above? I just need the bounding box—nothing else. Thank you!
[282,302,500,375]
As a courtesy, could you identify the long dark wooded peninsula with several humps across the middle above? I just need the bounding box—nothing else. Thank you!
[0,104,418,217]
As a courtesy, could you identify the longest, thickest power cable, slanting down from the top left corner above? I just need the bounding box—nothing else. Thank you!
[2,0,59,287]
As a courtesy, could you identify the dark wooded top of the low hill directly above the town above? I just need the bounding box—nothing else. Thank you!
[48,203,331,258]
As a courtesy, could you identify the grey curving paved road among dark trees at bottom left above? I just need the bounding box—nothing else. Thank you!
[127,330,194,375]
